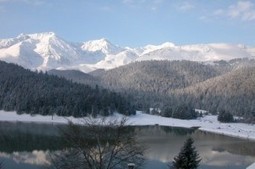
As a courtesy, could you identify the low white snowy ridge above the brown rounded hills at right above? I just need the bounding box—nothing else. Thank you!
[137,44,252,62]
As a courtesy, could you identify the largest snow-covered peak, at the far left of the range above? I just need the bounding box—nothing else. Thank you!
[0,32,84,70]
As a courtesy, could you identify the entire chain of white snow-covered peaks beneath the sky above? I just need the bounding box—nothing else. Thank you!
[0,32,255,72]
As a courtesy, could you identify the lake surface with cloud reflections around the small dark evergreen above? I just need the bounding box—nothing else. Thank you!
[134,126,255,169]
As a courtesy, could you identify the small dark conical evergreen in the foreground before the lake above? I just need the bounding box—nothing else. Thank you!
[170,137,201,169]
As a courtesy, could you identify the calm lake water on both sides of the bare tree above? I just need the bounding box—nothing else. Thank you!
[0,122,255,169]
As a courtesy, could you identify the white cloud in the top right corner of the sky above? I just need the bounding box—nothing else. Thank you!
[213,1,255,21]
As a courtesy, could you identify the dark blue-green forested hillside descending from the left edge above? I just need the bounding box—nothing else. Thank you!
[0,61,135,117]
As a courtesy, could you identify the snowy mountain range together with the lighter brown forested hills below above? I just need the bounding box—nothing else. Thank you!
[0,32,255,119]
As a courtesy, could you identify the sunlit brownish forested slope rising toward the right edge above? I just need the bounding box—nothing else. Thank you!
[174,66,255,116]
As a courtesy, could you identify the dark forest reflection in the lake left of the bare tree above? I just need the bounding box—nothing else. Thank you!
[0,122,64,153]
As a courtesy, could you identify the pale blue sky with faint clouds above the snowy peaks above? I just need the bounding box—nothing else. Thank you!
[0,0,255,47]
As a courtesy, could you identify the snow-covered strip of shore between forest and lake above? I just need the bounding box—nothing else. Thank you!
[0,111,255,141]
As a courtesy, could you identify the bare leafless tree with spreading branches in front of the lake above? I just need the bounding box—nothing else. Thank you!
[52,119,145,169]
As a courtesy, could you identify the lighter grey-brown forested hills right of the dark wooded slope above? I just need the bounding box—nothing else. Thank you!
[49,59,255,116]
